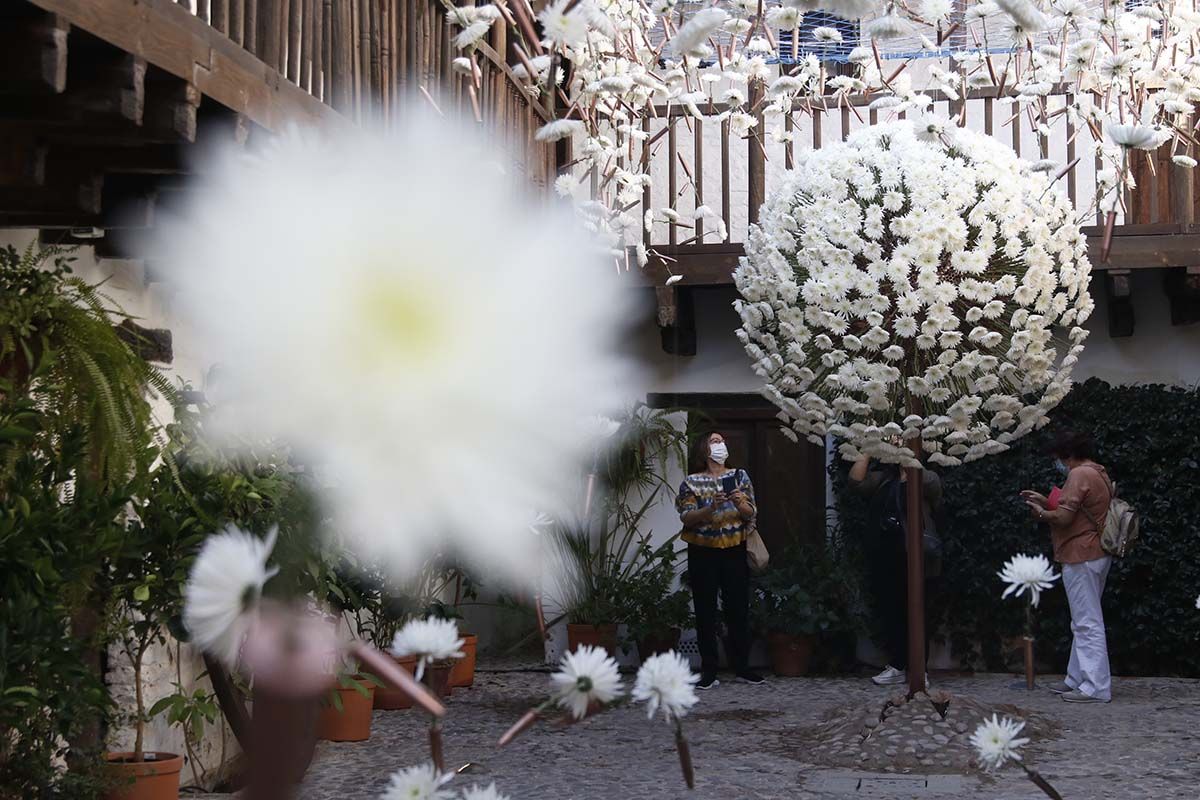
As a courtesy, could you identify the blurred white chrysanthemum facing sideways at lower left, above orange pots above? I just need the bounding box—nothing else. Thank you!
[184,525,278,668]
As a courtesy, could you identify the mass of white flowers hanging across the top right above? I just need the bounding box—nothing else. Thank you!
[446,0,1200,281]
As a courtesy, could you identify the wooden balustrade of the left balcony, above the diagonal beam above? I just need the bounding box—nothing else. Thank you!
[170,0,556,186]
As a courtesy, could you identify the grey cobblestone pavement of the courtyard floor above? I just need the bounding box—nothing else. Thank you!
[193,670,1200,800]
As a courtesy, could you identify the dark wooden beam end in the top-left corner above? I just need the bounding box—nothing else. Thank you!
[0,4,71,95]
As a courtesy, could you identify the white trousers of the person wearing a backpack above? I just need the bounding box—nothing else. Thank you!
[1062,555,1112,700]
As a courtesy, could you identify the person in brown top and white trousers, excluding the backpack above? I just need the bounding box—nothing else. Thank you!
[1021,431,1112,703]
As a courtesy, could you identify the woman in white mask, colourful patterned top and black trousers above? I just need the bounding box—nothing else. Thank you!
[676,432,763,688]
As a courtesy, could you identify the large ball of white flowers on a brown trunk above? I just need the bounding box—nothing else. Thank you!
[734,120,1093,692]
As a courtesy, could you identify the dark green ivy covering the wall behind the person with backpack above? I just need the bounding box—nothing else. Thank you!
[836,379,1200,675]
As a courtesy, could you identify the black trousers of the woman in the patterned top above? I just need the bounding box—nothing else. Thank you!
[688,545,750,673]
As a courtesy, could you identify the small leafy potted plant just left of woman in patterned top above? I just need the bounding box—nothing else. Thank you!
[622,537,692,661]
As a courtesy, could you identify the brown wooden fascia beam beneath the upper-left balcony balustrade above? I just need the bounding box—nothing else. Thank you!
[24,0,340,130]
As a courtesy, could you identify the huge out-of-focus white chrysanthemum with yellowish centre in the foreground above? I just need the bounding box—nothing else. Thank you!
[155,115,637,583]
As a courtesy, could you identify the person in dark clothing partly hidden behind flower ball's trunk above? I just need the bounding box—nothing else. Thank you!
[850,457,942,686]
